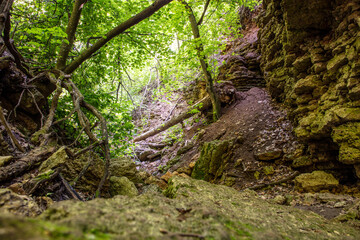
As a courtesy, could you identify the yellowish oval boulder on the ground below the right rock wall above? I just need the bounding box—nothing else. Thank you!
[295,171,339,192]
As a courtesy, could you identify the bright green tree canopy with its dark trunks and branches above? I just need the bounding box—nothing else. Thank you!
[2,0,258,195]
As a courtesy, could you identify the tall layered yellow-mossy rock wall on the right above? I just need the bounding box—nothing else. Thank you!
[258,0,360,177]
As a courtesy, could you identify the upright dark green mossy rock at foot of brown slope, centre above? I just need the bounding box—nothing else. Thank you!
[191,140,233,181]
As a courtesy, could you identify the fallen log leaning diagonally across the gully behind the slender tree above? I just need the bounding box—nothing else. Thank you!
[133,97,211,142]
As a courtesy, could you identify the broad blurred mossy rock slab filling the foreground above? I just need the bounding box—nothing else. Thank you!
[0,177,360,240]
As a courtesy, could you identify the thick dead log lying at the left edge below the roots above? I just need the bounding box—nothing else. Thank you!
[0,147,55,182]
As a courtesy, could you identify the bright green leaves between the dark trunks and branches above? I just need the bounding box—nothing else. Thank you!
[11,0,258,155]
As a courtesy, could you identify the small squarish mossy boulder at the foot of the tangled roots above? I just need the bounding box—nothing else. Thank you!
[110,176,139,197]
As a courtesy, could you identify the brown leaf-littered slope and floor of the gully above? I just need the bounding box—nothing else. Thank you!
[133,85,360,223]
